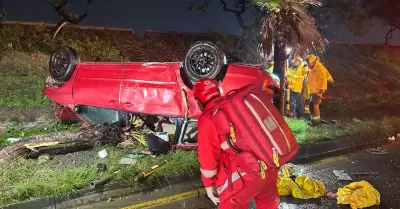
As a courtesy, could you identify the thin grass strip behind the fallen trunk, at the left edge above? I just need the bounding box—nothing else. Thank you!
[0,121,78,148]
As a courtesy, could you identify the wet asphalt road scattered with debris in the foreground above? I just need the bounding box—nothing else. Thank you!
[79,144,400,209]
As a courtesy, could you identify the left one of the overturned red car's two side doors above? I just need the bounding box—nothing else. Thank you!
[73,63,125,109]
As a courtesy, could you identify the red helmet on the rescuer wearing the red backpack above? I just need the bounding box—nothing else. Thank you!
[193,78,221,103]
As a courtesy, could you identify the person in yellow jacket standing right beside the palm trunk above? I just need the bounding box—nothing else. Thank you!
[287,57,308,118]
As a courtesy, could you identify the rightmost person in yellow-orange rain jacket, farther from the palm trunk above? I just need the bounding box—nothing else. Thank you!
[307,54,334,125]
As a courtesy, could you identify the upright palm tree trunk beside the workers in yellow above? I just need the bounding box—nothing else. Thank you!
[274,38,286,115]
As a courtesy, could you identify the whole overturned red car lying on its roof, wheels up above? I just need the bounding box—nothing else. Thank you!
[43,42,279,147]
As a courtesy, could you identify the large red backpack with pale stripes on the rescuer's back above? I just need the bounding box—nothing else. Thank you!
[212,84,299,178]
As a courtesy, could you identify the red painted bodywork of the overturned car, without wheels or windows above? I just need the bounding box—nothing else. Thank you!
[43,63,280,118]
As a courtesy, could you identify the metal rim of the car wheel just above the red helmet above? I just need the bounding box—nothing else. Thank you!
[190,49,216,77]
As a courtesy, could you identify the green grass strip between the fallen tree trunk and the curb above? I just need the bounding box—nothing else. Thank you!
[0,147,199,205]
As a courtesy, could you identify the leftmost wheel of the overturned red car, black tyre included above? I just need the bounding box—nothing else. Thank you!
[49,47,80,81]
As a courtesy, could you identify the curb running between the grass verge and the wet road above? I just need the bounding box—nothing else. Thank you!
[3,139,387,209]
